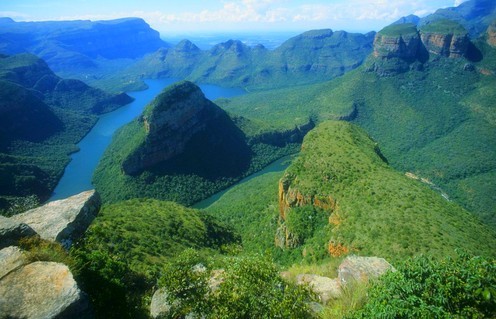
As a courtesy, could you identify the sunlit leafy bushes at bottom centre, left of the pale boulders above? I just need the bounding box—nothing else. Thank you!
[160,251,312,319]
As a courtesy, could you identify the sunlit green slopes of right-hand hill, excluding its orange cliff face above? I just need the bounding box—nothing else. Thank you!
[207,122,496,265]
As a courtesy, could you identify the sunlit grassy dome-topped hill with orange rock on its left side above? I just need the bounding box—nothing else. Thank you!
[281,122,496,262]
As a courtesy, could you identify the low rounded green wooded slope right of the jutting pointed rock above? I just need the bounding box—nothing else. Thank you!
[78,199,236,275]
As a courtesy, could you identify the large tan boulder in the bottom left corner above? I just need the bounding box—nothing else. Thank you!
[0,261,91,319]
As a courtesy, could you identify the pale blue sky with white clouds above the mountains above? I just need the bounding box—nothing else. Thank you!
[0,0,463,34]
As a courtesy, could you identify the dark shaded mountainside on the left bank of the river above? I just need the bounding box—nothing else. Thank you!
[0,54,130,215]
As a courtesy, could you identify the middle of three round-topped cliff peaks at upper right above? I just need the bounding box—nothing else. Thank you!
[420,20,470,58]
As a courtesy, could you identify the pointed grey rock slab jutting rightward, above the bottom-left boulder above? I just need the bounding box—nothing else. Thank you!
[12,190,101,247]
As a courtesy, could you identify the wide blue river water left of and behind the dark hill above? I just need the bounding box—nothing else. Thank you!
[50,79,245,201]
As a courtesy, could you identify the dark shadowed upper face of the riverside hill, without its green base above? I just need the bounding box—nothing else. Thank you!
[122,81,247,175]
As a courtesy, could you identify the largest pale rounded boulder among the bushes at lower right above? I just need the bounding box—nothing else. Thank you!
[338,256,395,286]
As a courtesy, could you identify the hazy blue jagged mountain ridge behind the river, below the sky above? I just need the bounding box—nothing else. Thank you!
[122,29,374,90]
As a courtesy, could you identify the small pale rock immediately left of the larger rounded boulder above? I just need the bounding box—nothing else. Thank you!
[296,274,342,305]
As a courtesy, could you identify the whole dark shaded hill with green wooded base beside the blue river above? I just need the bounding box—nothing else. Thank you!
[94,82,295,205]
